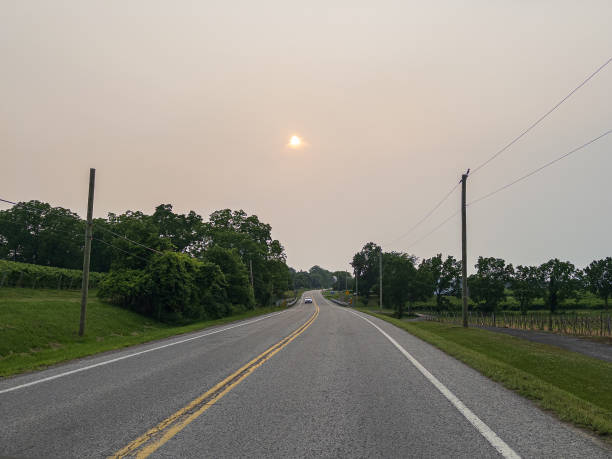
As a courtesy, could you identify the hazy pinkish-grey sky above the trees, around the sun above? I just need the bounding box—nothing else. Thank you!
[0,0,612,269]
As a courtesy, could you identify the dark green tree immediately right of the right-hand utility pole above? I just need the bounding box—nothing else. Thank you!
[468,257,513,312]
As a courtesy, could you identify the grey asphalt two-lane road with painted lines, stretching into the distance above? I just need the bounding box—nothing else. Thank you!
[0,292,612,458]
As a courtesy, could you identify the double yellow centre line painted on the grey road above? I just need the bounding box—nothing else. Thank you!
[110,301,319,458]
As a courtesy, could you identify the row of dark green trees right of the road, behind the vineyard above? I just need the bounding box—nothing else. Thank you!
[351,242,612,317]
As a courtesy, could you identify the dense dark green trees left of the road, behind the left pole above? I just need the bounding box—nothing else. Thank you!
[0,201,293,319]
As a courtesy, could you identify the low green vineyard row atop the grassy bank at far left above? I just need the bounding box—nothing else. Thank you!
[0,260,106,289]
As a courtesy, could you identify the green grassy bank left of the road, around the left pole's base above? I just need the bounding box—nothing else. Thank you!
[0,288,279,377]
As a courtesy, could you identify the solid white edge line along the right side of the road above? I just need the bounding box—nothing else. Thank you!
[347,309,521,459]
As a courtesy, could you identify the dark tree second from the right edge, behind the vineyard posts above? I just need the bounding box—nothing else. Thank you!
[539,258,579,320]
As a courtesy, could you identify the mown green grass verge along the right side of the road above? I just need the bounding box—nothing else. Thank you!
[359,308,612,443]
